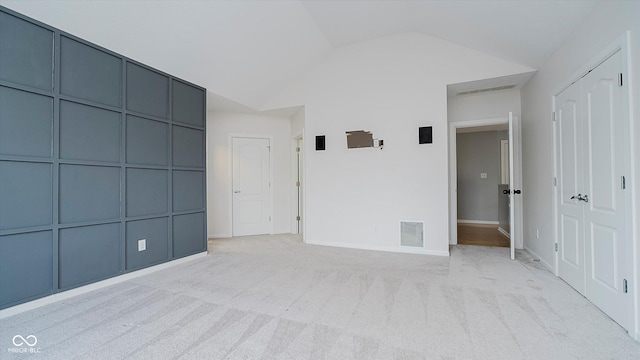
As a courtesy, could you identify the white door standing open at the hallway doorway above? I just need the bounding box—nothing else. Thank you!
[509,112,522,260]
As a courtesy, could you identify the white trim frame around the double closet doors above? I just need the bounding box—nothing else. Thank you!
[550,30,640,334]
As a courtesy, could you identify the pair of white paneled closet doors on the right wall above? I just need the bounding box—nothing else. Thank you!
[555,52,631,329]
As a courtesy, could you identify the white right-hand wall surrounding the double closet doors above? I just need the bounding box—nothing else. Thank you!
[522,1,640,340]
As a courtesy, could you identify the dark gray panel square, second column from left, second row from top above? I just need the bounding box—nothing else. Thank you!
[60,101,121,162]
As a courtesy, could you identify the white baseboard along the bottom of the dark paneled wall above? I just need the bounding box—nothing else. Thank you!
[0,251,207,319]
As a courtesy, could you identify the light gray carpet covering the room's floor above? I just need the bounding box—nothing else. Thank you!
[0,235,640,360]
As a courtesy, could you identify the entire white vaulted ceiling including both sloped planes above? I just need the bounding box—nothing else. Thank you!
[0,0,597,109]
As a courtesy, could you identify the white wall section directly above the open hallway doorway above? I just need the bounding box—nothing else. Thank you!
[447,89,520,122]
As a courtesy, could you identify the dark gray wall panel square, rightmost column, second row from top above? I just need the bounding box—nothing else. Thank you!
[173,126,204,167]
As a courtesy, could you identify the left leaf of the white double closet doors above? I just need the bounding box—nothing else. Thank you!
[555,83,585,294]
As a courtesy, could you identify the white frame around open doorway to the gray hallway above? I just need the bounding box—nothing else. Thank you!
[449,114,510,248]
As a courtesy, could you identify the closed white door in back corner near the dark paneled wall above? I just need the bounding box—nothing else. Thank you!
[232,137,271,236]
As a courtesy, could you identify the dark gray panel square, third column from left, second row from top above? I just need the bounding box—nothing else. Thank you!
[127,115,169,165]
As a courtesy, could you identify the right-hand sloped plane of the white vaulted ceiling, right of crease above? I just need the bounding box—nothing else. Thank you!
[302,0,597,68]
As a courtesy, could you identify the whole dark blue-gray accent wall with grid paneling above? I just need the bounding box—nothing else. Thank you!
[0,7,207,309]
